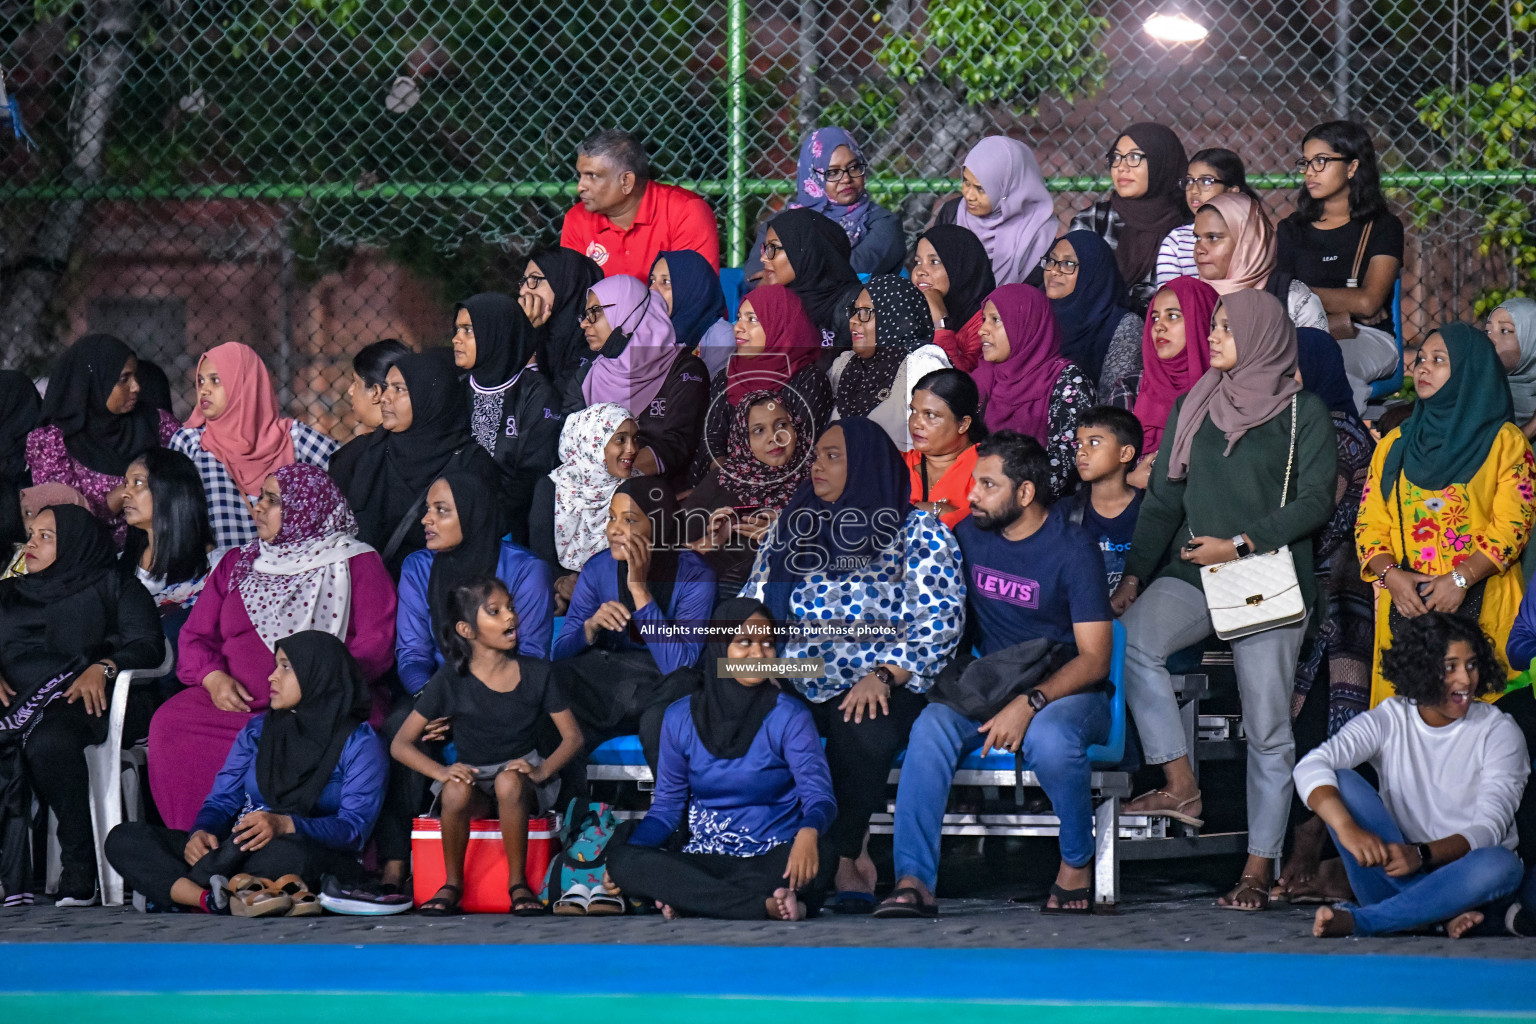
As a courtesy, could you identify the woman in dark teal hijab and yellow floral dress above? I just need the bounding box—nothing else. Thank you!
[1355,324,1536,708]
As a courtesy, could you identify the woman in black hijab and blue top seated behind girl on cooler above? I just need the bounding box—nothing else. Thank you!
[376,470,554,892]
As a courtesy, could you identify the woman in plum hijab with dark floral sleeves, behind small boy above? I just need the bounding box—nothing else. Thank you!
[971,284,1097,497]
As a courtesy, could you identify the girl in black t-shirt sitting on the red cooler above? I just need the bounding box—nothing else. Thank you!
[390,576,582,917]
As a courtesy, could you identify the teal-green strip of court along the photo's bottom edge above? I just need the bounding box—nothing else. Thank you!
[0,994,1536,1024]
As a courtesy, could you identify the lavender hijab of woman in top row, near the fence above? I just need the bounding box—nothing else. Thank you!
[955,135,1057,286]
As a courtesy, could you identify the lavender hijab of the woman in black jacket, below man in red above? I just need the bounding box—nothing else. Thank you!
[581,275,679,416]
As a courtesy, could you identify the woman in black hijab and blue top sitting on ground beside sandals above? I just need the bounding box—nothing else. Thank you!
[106,629,387,917]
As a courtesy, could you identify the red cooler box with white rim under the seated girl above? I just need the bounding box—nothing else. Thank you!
[410,814,561,913]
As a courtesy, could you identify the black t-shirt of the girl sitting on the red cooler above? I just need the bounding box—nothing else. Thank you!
[416,656,570,766]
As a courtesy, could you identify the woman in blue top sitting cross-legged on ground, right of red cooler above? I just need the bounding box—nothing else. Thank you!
[604,597,837,921]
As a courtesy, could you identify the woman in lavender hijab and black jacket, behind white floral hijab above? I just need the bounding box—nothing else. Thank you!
[567,275,710,487]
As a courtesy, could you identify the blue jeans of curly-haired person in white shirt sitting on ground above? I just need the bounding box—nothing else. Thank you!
[1330,771,1524,935]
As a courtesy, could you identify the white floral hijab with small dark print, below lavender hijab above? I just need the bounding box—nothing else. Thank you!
[550,402,634,571]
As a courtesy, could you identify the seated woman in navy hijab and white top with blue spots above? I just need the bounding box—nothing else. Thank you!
[742,416,965,913]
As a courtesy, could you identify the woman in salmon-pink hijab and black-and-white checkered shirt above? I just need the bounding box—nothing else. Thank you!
[166,341,338,550]
